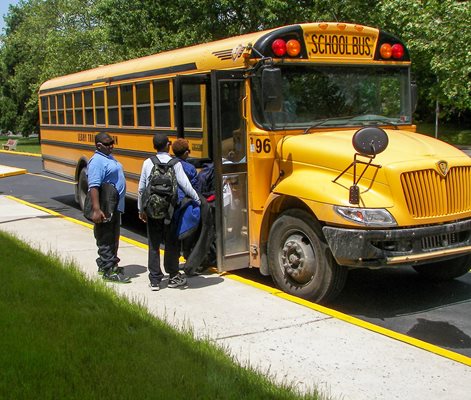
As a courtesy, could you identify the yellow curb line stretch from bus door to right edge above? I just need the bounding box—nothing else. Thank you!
[224,272,471,366]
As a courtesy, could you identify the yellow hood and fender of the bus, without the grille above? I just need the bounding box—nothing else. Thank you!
[272,129,471,216]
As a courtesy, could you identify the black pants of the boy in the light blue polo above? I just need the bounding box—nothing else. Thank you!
[93,211,121,272]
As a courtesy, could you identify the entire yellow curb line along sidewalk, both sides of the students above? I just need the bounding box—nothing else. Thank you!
[5,196,471,366]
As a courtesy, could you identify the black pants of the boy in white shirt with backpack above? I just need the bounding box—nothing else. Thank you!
[147,218,180,283]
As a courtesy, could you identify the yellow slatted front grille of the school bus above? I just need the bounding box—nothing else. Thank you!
[401,167,471,218]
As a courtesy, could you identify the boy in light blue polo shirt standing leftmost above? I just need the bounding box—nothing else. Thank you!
[87,132,131,283]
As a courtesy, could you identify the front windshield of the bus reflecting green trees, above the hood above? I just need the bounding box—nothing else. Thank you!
[252,65,411,130]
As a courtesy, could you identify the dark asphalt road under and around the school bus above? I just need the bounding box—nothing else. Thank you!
[0,153,471,357]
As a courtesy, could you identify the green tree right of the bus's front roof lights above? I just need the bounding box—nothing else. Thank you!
[380,0,471,120]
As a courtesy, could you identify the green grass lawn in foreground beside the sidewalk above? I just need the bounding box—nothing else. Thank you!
[0,231,319,400]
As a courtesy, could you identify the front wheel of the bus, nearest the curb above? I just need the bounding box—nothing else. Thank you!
[268,210,348,303]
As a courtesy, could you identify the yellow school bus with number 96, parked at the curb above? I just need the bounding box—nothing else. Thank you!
[39,23,471,301]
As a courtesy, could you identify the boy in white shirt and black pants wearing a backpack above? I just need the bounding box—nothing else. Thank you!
[137,133,200,291]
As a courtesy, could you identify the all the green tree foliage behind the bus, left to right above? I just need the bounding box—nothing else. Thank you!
[0,0,471,133]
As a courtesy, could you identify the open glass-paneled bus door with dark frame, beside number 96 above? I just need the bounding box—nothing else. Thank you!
[211,71,250,272]
